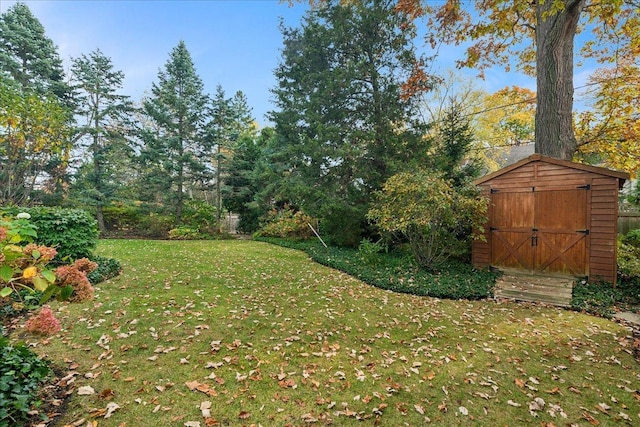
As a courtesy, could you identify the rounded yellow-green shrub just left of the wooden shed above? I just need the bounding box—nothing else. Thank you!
[367,171,488,270]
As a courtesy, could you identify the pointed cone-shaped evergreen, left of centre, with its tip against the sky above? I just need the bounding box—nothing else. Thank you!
[141,41,211,224]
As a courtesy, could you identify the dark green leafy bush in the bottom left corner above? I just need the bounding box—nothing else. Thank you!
[0,337,53,426]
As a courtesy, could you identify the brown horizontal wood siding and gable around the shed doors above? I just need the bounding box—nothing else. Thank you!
[472,155,625,283]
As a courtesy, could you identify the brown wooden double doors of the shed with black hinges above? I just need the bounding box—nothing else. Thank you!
[490,185,590,276]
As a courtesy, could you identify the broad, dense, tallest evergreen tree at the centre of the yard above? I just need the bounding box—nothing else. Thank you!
[271,0,431,245]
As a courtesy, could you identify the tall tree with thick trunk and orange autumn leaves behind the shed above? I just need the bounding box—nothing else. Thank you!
[398,0,640,167]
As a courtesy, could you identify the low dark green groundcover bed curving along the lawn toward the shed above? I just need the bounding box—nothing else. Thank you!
[257,238,497,300]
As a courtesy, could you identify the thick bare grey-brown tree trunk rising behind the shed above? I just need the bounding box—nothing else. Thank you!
[535,0,586,160]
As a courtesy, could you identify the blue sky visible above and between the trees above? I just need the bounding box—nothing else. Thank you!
[0,0,596,125]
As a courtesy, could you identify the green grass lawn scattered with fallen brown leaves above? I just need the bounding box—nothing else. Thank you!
[23,240,640,427]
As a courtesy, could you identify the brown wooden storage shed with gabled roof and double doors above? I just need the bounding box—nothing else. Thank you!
[472,154,629,283]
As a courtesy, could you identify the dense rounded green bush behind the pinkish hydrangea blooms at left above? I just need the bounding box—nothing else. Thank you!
[2,207,99,263]
